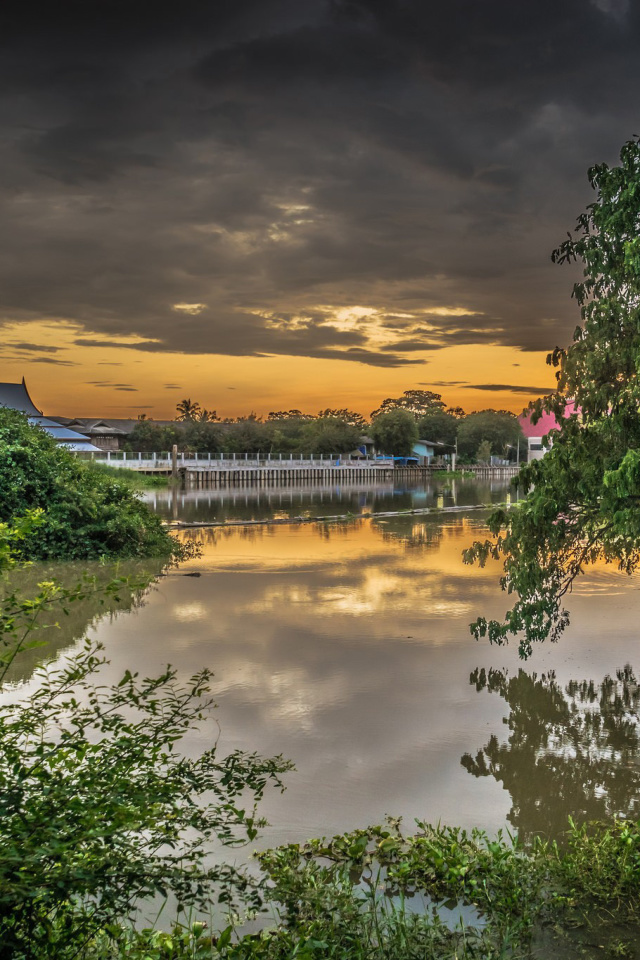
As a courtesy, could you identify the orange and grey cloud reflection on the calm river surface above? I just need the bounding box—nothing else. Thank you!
[5,513,637,844]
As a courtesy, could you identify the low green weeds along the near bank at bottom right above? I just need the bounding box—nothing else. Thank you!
[84,821,640,960]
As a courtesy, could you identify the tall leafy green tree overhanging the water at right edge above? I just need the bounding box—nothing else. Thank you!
[466,139,640,656]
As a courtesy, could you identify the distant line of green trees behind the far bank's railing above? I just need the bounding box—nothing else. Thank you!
[127,390,524,463]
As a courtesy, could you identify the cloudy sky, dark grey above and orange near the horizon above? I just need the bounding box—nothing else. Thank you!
[0,0,640,418]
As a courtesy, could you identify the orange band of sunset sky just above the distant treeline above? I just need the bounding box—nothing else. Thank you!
[3,322,555,419]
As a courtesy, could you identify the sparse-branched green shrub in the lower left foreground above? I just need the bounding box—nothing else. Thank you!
[0,511,290,960]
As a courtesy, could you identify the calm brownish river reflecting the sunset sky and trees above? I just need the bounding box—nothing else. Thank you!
[5,481,640,846]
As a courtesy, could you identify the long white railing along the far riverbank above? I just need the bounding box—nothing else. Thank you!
[82,450,393,470]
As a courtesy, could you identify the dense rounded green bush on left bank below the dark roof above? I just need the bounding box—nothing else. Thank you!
[0,408,181,559]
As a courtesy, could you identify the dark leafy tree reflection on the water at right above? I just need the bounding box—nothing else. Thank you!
[461,665,640,840]
